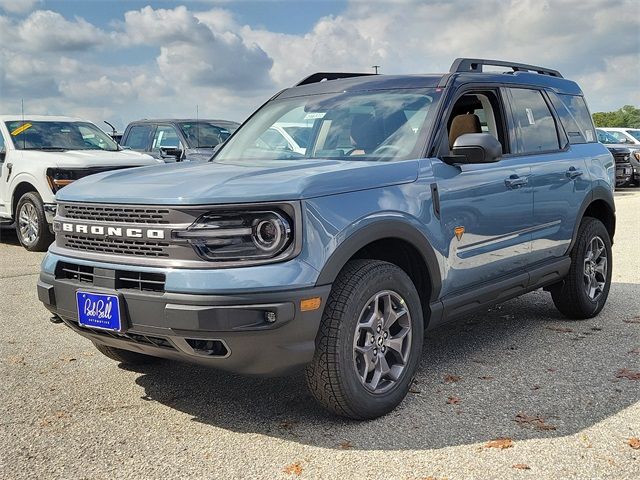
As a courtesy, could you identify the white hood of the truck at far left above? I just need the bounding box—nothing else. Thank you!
[19,150,160,168]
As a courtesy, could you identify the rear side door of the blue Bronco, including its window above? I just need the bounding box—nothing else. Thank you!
[508,88,595,263]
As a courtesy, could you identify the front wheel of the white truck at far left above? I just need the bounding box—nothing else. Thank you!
[15,192,54,252]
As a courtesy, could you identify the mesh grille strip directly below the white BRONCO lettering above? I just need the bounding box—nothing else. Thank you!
[64,235,169,257]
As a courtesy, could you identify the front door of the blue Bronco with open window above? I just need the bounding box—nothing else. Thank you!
[432,88,533,295]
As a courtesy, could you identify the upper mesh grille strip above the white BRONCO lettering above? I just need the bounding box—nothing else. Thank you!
[62,203,170,225]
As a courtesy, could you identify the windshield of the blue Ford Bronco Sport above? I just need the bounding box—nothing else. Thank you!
[214,89,440,162]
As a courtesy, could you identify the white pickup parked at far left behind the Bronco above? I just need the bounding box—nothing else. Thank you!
[0,115,162,251]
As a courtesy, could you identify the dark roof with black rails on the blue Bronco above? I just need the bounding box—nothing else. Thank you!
[278,58,582,98]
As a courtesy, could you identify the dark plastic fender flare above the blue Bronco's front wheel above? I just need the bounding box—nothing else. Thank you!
[316,219,442,302]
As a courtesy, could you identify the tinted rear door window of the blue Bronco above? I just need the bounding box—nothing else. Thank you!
[510,88,560,153]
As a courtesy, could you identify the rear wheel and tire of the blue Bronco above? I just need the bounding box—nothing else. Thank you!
[550,217,613,320]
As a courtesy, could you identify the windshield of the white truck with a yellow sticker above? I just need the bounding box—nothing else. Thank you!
[6,120,119,152]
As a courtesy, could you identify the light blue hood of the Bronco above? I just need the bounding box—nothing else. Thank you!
[57,160,418,205]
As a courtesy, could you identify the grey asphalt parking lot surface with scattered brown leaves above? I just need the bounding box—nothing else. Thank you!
[0,190,640,479]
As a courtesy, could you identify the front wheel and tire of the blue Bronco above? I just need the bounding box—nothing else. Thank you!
[306,260,424,420]
